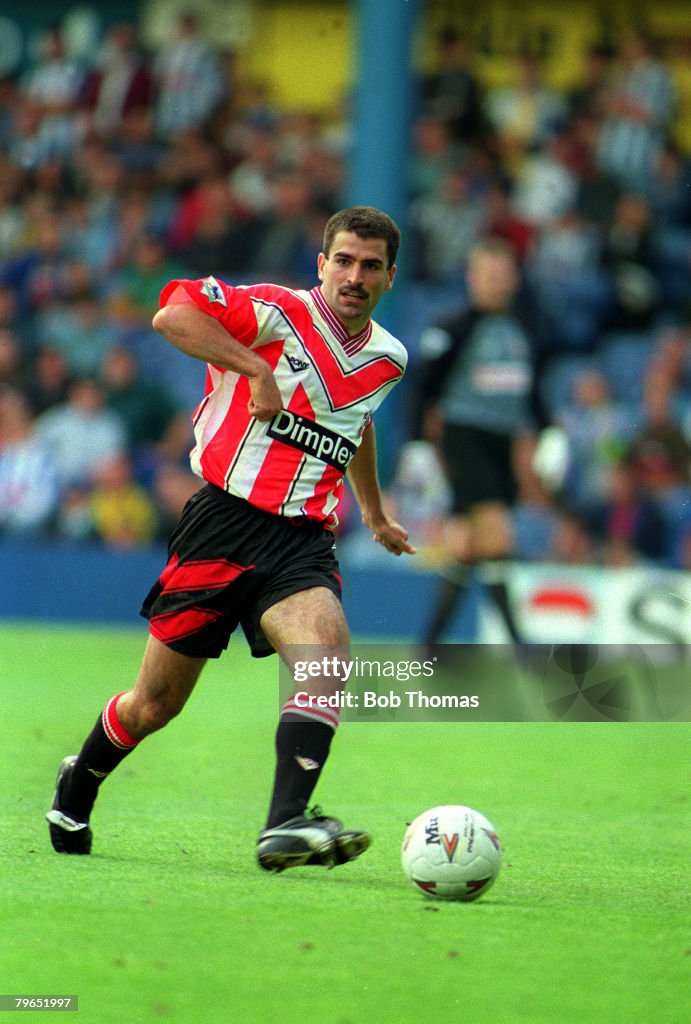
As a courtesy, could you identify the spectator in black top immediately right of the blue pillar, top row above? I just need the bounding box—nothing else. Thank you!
[420,27,482,142]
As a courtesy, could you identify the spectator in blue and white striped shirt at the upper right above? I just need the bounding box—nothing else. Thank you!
[598,29,676,191]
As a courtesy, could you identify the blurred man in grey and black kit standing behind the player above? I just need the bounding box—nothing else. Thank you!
[413,238,539,646]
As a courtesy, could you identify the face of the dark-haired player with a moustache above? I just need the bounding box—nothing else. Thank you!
[317,231,396,334]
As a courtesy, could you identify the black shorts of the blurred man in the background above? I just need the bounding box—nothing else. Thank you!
[441,423,517,515]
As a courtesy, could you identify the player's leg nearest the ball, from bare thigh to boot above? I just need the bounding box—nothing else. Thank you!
[257,587,370,871]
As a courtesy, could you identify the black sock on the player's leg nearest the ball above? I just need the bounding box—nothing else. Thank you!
[266,712,334,828]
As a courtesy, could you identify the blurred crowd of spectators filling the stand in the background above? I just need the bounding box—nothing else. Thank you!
[0,6,691,566]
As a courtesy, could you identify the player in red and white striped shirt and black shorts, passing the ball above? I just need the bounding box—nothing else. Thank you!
[47,207,415,871]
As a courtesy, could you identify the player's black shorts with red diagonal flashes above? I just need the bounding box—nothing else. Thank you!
[141,483,341,657]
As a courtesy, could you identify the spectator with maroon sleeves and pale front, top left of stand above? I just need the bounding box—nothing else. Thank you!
[80,24,154,139]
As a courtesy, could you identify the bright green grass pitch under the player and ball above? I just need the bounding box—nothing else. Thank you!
[0,626,691,1024]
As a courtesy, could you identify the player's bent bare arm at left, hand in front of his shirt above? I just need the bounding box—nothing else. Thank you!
[154,302,284,422]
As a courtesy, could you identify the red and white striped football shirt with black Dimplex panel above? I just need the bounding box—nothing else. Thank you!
[161,278,407,525]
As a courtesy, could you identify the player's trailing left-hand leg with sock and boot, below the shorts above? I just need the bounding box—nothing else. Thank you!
[46,636,205,854]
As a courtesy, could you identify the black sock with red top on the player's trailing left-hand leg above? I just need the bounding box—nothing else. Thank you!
[60,693,139,821]
